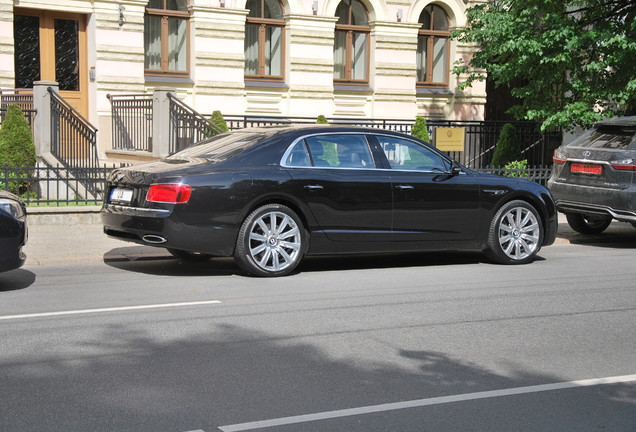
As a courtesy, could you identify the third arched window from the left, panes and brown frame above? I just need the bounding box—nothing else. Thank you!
[333,0,371,84]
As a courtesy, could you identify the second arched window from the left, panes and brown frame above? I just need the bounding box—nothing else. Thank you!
[245,0,285,80]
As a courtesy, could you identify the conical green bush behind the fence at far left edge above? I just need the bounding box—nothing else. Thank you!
[0,105,36,194]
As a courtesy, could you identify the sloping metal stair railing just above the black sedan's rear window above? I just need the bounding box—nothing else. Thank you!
[168,93,221,154]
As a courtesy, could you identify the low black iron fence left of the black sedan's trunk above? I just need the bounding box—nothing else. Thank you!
[0,165,124,206]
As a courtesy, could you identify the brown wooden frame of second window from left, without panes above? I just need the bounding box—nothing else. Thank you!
[243,0,287,82]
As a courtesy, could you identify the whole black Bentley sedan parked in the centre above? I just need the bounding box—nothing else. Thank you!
[101,125,556,276]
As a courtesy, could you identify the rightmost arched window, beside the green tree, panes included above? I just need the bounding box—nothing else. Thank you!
[417,5,450,87]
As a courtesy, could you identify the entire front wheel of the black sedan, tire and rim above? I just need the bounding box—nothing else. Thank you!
[484,200,544,264]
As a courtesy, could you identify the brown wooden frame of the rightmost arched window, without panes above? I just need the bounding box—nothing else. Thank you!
[416,4,451,88]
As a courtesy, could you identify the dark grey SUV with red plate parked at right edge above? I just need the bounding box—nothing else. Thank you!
[548,117,636,234]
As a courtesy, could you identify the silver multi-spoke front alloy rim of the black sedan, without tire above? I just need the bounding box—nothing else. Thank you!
[497,207,541,261]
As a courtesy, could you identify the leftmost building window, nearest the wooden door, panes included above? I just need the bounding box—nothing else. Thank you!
[144,0,190,75]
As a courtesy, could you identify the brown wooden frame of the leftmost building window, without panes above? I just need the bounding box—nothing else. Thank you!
[144,0,191,77]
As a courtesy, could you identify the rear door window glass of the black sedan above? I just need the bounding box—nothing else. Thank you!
[306,135,375,168]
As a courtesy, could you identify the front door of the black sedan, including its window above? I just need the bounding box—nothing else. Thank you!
[376,135,480,241]
